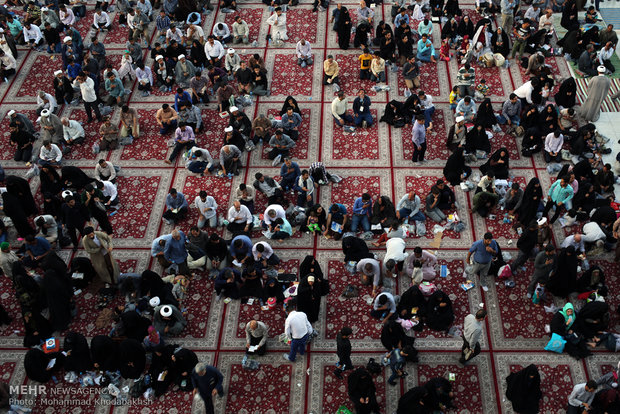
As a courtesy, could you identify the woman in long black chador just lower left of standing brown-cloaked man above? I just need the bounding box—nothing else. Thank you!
[43,269,73,331]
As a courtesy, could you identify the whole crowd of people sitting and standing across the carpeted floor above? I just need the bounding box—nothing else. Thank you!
[0,0,620,414]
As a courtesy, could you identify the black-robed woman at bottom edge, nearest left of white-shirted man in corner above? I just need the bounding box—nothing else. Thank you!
[506,364,542,414]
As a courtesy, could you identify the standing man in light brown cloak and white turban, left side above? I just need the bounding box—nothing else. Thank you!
[82,226,120,285]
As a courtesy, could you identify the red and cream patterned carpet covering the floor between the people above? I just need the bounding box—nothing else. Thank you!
[0,0,620,414]
